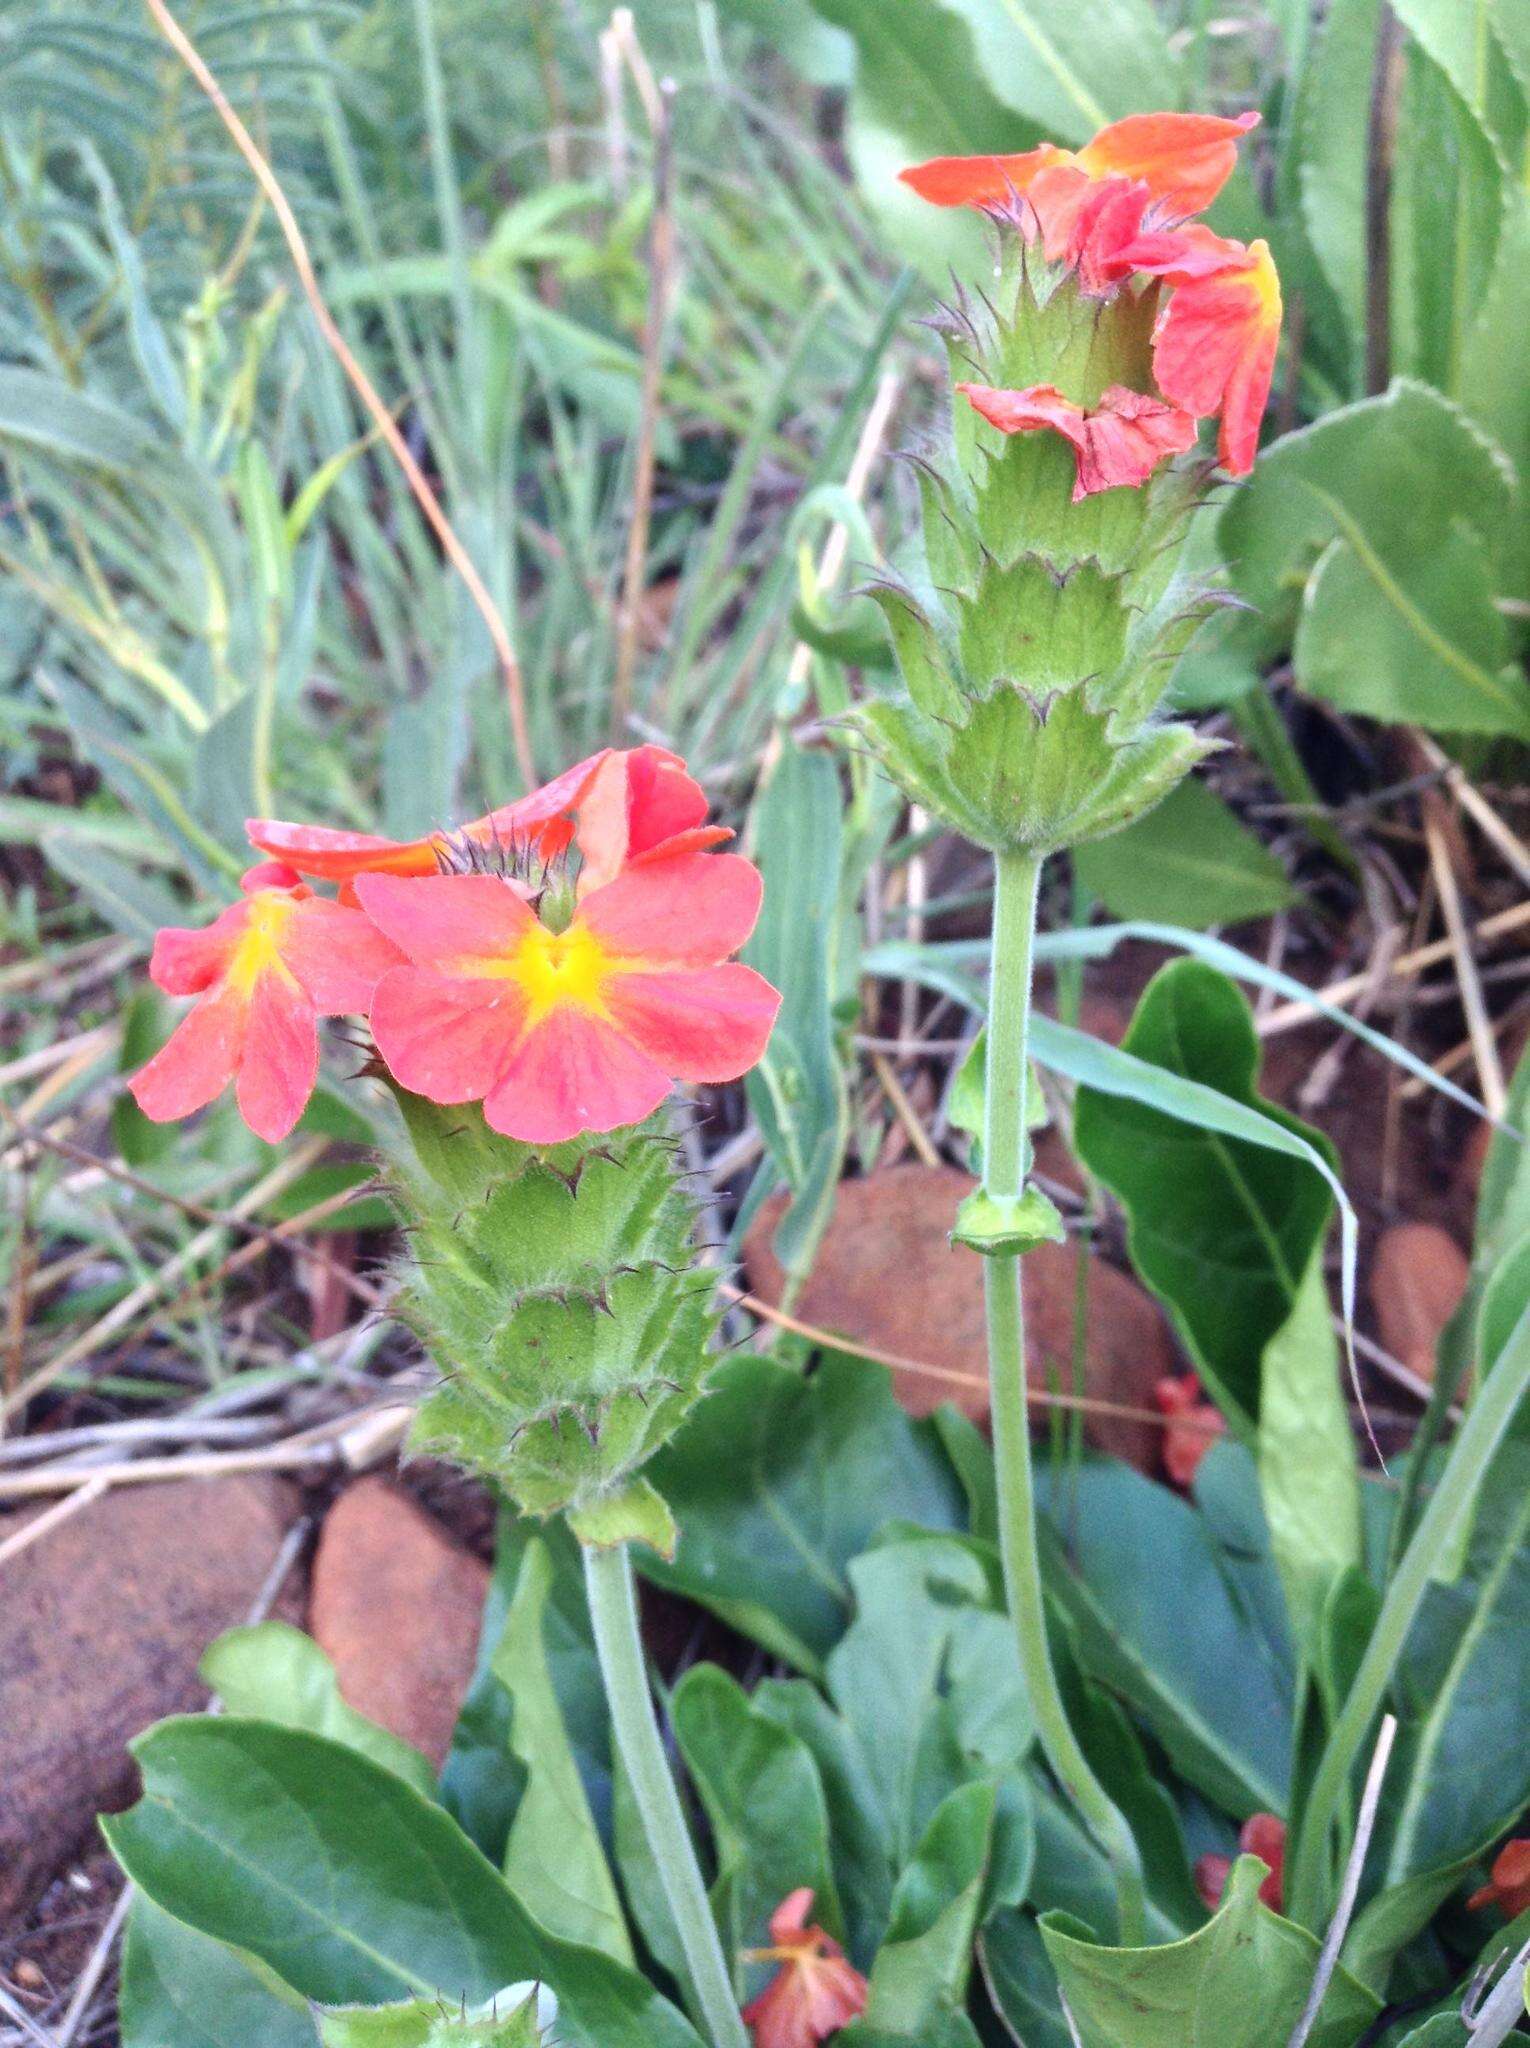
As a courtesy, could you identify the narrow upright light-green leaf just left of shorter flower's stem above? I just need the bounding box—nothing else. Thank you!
[494,1540,633,1964]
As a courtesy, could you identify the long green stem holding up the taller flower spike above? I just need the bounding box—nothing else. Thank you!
[983,854,1147,1948]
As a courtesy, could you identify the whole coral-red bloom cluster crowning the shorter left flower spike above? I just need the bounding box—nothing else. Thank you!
[131,745,778,1145]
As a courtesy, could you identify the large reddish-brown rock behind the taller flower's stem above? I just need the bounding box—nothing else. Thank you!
[743,1165,1178,1470]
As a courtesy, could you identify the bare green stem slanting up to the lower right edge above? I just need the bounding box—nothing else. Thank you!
[1286,1309,1530,1929]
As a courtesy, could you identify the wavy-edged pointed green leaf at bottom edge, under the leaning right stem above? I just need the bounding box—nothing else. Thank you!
[1040,1855,1380,2048]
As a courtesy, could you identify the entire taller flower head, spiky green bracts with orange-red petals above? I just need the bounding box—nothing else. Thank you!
[852,115,1280,860]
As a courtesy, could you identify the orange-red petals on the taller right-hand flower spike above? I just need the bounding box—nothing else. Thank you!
[903,115,1280,483]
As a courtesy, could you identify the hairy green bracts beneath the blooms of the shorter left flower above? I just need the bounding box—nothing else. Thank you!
[385,1092,717,1548]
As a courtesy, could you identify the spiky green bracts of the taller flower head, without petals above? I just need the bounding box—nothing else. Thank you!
[854,253,1213,858]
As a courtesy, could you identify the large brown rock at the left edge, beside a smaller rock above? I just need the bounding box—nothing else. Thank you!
[0,1475,297,1921]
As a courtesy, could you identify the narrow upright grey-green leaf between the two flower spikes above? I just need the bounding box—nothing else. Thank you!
[743,743,850,1274]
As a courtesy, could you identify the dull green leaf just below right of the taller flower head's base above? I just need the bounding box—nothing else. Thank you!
[1073,776,1297,926]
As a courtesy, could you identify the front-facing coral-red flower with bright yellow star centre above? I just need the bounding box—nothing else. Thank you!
[354,827,780,1145]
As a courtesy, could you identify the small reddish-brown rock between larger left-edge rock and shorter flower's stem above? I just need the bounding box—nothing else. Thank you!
[309,1479,490,1765]
